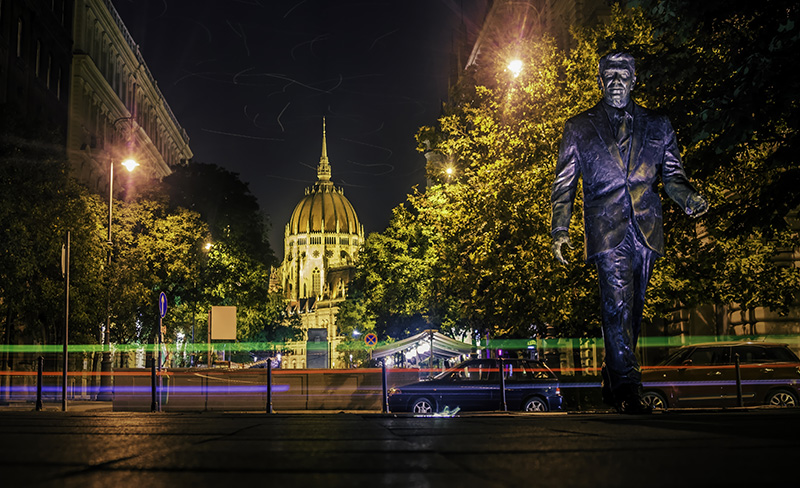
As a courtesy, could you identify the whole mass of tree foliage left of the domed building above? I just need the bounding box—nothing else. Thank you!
[0,131,299,362]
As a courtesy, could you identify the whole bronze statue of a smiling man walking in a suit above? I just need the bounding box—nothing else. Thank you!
[551,53,708,414]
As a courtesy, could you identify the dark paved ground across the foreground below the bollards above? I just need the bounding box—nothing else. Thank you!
[0,409,800,488]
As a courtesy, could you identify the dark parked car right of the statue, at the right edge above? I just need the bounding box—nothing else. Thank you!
[642,342,800,408]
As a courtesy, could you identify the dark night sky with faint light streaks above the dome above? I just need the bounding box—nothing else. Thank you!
[113,0,485,258]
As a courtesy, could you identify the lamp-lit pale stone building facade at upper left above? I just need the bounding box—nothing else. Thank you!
[67,0,192,190]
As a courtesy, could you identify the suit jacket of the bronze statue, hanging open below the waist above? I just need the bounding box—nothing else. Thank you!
[551,101,695,260]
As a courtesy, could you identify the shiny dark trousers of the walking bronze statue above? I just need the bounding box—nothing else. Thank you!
[593,224,659,401]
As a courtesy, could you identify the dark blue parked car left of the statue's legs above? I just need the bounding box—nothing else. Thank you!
[389,359,561,414]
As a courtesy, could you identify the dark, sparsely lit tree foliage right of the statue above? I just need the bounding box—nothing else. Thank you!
[583,0,800,320]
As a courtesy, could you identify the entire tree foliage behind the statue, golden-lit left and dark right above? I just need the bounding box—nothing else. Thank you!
[350,0,800,346]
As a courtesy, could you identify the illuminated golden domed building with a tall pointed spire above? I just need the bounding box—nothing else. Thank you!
[281,119,364,369]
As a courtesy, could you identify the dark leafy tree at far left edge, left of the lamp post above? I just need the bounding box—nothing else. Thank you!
[0,132,104,350]
